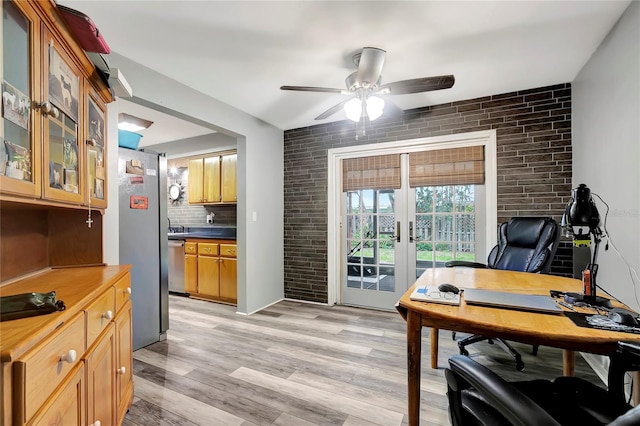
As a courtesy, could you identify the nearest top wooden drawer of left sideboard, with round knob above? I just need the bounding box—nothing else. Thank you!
[13,312,85,424]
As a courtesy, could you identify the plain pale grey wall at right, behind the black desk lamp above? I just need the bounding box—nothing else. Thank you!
[572,2,640,309]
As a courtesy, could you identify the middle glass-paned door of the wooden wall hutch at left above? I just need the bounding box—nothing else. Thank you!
[42,28,86,204]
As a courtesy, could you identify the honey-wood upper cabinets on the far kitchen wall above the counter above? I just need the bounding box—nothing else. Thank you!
[188,154,238,204]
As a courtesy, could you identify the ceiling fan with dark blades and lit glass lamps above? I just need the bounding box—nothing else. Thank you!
[280,47,455,122]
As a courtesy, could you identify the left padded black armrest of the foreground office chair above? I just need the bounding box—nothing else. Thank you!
[449,355,560,426]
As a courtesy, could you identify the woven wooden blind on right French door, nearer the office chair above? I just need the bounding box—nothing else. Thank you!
[409,146,484,188]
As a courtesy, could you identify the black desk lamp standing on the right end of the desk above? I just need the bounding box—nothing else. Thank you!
[560,183,611,308]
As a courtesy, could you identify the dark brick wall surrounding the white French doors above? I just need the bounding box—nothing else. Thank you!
[284,83,573,302]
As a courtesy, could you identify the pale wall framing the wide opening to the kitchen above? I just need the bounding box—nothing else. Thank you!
[104,52,284,313]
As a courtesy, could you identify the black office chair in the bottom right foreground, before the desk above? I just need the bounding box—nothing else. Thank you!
[445,342,640,426]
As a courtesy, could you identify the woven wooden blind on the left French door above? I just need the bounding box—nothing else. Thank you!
[342,154,400,192]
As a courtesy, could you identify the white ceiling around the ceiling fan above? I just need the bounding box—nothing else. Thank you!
[59,0,630,130]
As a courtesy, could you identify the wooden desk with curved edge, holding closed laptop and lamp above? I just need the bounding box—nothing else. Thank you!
[396,267,640,426]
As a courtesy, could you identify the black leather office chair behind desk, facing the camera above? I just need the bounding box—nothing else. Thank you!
[445,217,560,370]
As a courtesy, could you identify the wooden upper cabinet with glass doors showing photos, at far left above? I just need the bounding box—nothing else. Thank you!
[0,1,111,208]
